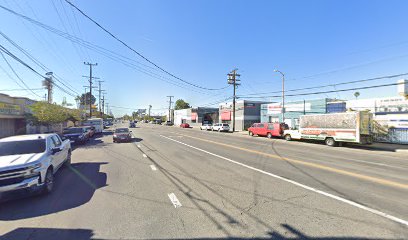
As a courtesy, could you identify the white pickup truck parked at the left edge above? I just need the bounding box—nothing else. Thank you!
[0,133,71,200]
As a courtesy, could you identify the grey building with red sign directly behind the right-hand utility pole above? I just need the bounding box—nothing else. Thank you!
[219,100,266,131]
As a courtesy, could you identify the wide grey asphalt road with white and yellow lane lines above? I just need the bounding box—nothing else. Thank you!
[0,124,408,240]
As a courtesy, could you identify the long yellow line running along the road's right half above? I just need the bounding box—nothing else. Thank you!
[167,135,408,189]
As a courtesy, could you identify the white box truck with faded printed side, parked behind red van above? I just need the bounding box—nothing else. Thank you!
[283,111,373,146]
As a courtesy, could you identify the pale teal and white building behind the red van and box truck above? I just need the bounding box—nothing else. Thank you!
[261,98,345,128]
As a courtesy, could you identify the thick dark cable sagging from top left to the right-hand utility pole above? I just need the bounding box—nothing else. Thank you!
[65,0,227,91]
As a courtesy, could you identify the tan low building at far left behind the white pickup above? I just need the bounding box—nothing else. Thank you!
[0,93,35,138]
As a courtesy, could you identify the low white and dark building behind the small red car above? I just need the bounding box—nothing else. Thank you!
[174,107,218,126]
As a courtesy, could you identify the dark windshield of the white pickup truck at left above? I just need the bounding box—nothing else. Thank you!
[0,139,45,156]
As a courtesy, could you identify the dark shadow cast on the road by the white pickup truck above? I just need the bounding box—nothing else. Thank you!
[0,162,107,221]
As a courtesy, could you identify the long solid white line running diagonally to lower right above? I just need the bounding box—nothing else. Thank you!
[160,135,408,226]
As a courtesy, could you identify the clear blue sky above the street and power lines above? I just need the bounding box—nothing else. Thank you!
[0,0,408,115]
